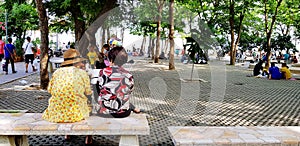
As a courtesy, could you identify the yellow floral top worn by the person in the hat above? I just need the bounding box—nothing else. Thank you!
[43,66,92,123]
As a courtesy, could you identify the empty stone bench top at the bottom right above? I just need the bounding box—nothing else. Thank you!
[168,126,300,146]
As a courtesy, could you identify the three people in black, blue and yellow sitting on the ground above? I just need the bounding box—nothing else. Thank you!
[253,60,292,80]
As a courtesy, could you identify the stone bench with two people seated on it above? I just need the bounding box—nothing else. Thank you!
[0,113,150,146]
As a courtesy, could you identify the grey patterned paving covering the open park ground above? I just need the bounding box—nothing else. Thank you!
[0,57,300,146]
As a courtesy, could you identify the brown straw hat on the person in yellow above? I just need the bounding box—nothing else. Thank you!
[61,49,87,66]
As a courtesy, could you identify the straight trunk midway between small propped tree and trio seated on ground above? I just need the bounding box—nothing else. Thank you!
[229,0,236,65]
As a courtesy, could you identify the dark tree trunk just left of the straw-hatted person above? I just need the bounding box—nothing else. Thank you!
[36,0,49,89]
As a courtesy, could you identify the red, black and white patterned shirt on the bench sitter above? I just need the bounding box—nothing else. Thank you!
[98,66,134,114]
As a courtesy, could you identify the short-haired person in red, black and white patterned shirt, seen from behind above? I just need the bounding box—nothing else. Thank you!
[98,47,134,118]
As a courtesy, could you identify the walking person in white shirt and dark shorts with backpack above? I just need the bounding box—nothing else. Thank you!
[22,37,37,73]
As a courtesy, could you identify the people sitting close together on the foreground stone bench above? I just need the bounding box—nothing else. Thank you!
[42,38,143,144]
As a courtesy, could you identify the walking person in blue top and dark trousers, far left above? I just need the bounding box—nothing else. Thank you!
[4,38,17,74]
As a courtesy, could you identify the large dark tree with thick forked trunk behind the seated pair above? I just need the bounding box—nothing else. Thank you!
[47,0,118,56]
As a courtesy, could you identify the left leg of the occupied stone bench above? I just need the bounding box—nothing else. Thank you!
[0,135,29,146]
